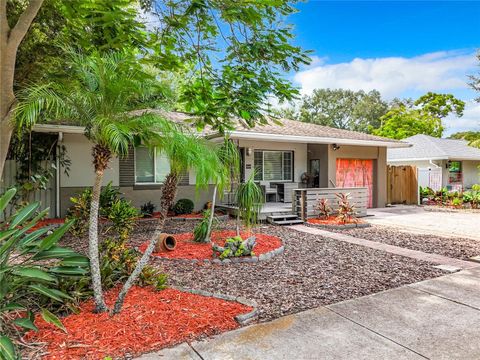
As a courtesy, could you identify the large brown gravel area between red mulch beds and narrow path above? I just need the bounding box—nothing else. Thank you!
[60,220,445,321]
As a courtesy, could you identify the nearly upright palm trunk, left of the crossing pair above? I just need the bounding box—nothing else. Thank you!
[88,170,108,312]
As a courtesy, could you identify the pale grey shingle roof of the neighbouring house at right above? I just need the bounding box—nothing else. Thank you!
[387,134,480,161]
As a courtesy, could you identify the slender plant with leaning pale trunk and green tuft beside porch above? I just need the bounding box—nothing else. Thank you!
[204,137,240,242]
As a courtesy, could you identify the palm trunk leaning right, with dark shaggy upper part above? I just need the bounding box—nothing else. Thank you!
[113,173,178,314]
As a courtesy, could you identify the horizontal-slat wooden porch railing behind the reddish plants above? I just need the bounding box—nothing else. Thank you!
[292,187,368,220]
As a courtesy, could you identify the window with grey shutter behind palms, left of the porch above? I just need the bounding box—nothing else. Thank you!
[135,146,170,184]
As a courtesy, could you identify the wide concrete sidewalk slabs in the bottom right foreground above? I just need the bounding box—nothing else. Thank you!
[140,268,480,360]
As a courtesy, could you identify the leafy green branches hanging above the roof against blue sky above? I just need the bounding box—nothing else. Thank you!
[144,0,310,131]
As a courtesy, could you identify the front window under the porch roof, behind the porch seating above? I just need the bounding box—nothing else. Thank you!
[253,150,293,181]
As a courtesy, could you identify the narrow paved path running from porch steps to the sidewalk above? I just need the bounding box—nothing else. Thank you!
[289,225,479,272]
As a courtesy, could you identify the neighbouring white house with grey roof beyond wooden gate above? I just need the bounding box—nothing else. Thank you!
[388,135,480,190]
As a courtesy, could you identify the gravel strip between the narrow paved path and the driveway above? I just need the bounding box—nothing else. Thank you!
[335,225,480,260]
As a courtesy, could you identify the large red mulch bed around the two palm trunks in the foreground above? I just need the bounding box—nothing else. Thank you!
[26,287,252,359]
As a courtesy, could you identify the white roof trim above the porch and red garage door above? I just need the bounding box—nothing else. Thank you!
[226,131,412,148]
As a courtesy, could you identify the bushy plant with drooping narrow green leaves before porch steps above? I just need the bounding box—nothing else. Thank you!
[236,172,265,235]
